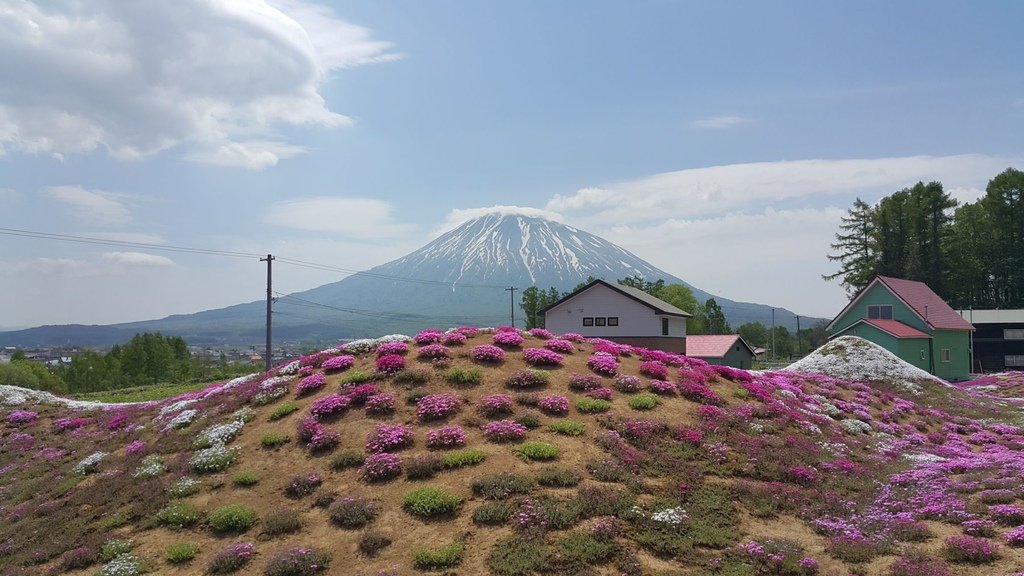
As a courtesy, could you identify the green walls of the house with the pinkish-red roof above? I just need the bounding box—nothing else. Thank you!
[833,283,971,380]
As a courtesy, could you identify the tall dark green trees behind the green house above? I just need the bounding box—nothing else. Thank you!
[823,168,1024,308]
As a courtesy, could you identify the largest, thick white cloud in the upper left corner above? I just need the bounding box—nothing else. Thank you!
[0,0,398,168]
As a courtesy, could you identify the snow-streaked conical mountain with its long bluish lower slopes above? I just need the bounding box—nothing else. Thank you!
[0,213,817,345]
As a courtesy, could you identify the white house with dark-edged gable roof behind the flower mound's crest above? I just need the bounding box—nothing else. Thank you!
[541,280,691,354]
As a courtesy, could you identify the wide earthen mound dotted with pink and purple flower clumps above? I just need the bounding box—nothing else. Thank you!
[0,329,1024,576]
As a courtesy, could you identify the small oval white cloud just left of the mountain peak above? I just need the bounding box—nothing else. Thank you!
[265,197,415,240]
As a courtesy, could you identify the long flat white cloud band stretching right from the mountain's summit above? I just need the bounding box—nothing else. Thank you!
[546,155,1021,222]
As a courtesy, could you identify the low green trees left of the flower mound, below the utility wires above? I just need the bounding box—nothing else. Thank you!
[0,332,261,394]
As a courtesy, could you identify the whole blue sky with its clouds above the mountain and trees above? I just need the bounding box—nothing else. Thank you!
[0,0,1024,328]
